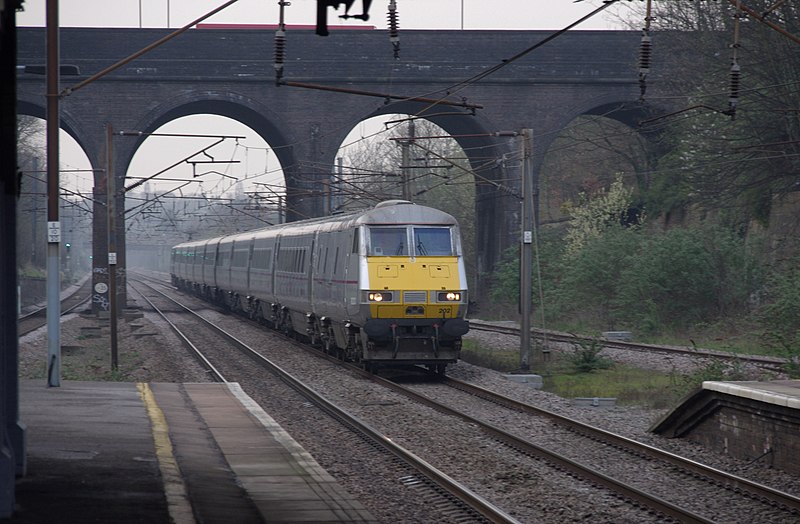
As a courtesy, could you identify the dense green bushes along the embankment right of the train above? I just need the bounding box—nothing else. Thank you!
[492,220,764,338]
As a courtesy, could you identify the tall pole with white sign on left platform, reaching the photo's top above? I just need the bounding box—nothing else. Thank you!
[47,0,61,387]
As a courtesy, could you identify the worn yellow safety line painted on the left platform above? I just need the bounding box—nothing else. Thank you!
[136,382,195,524]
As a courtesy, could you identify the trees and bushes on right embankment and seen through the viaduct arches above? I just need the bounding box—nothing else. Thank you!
[19,4,800,382]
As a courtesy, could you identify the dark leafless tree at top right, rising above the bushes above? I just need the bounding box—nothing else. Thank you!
[632,0,800,225]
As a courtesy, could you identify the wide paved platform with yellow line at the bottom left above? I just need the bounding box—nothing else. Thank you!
[8,380,375,524]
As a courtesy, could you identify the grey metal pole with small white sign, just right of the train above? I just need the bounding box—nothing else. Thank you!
[518,129,534,372]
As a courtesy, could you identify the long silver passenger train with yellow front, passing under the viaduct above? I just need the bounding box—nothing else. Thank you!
[170,200,469,374]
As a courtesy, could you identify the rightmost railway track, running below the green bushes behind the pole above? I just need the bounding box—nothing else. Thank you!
[469,320,788,371]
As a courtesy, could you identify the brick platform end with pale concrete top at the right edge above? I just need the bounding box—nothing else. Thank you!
[651,380,800,474]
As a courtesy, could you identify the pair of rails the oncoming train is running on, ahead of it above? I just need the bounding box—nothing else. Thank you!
[133,274,800,522]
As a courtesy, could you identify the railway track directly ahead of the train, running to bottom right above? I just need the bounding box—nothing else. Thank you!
[306,360,800,523]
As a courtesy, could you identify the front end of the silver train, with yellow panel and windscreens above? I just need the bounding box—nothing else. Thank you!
[350,201,469,373]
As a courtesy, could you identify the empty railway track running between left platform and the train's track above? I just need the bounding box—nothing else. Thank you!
[128,279,518,523]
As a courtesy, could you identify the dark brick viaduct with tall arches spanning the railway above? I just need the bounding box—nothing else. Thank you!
[17,28,642,302]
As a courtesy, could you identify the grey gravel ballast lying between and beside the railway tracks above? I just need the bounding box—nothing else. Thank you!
[19,295,800,523]
